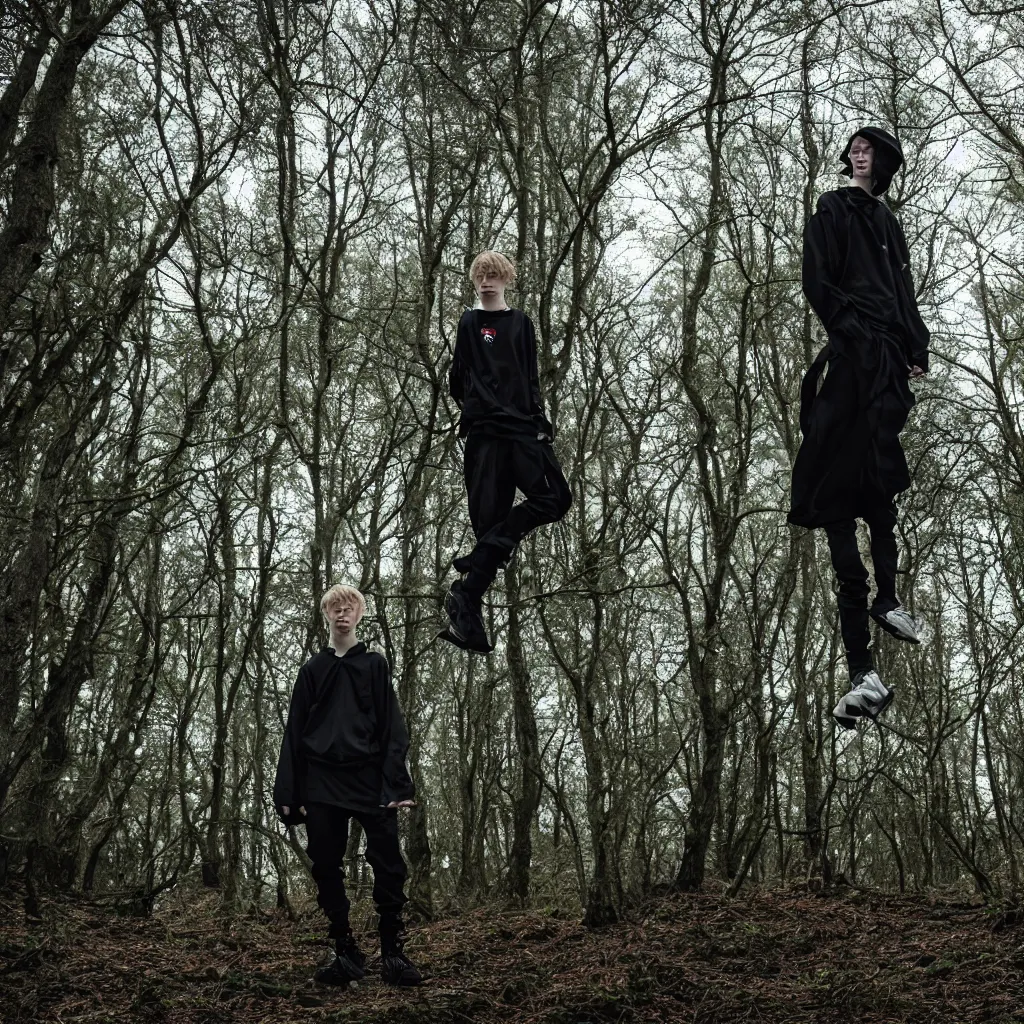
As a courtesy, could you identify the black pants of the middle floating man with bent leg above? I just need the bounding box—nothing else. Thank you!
[464,434,572,600]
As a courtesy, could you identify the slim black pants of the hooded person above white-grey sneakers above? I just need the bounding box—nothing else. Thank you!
[824,504,899,678]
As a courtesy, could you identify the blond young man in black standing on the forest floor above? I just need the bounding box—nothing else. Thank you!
[273,584,422,986]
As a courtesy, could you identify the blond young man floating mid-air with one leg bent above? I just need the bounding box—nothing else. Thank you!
[440,251,572,653]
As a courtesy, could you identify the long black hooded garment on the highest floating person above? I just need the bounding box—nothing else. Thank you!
[788,128,929,527]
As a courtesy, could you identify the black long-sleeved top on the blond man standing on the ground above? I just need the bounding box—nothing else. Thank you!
[273,643,415,822]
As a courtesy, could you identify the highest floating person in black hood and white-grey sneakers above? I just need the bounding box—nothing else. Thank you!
[788,127,929,729]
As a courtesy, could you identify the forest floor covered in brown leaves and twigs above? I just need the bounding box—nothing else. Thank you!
[0,889,1024,1024]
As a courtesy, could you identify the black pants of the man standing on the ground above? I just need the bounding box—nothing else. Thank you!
[305,804,407,939]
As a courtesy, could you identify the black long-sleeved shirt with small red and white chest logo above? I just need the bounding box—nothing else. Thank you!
[449,309,554,440]
